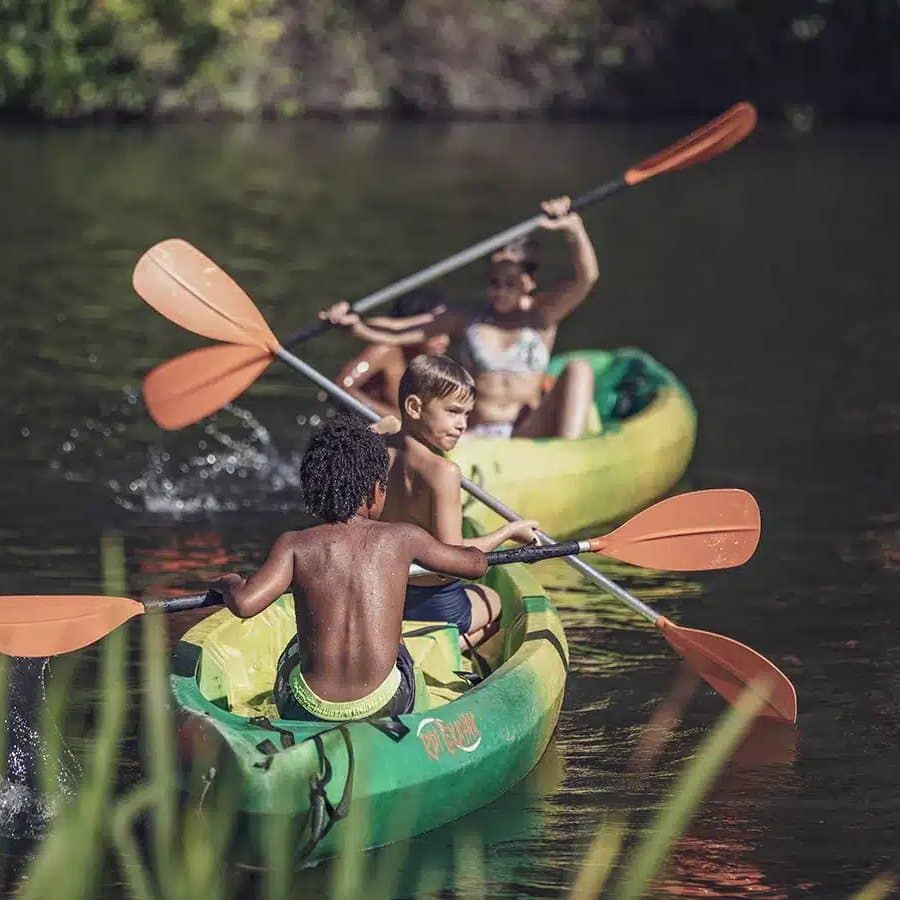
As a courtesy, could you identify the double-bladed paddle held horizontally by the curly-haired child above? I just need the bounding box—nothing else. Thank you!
[0,489,760,656]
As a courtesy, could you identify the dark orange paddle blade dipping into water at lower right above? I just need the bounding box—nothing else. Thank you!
[656,616,797,722]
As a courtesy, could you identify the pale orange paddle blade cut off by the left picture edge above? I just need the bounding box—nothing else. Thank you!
[0,594,144,656]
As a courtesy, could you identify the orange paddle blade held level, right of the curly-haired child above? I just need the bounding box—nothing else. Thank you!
[591,488,760,572]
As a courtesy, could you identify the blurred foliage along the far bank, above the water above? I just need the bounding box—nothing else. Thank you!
[0,0,900,119]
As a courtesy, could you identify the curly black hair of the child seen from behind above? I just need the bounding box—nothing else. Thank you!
[300,416,388,522]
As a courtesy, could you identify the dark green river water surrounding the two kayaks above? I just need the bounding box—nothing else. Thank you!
[0,123,900,897]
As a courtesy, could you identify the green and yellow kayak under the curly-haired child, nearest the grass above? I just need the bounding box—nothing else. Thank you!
[171,536,568,865]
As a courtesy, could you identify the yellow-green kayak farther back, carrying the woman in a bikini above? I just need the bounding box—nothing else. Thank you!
[451,349,697,536]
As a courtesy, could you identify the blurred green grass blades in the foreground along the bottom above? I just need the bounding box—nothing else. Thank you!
[0,615,895,900]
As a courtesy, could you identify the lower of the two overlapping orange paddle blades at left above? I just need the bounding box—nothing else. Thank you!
[144,344,274,431]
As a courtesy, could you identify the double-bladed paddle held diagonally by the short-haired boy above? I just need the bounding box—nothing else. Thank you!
[133,239,797,722]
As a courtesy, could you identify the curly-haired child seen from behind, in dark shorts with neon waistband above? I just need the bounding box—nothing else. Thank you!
[211,417,486,722]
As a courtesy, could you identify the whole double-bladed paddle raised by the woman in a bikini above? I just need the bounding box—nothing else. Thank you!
[141,103,756,429]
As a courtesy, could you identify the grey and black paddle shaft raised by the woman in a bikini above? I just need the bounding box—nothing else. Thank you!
[283,176,628,347]
